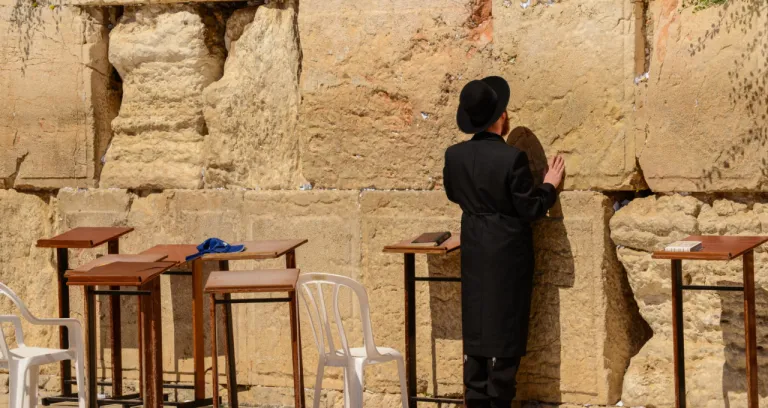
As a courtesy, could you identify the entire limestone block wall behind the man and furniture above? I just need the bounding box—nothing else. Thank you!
[0,0,768,407]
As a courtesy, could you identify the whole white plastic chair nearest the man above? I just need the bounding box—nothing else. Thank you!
[298,273,408,408]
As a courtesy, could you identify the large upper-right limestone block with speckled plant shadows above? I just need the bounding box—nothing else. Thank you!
[638,0,768,191]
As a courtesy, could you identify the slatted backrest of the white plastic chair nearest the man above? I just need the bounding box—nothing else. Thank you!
[298,273,379,357]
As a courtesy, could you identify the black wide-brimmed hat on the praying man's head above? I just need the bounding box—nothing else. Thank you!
[456,76,509,133]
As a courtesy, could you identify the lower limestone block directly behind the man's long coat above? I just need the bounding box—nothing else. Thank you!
[361,192,644,404]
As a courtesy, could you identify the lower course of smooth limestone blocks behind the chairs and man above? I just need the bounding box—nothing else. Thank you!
[0,189,643,406]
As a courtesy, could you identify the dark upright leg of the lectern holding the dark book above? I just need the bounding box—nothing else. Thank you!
[404,254,418,408]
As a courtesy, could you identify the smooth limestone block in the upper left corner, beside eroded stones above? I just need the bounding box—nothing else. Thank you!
[0,5,119,189]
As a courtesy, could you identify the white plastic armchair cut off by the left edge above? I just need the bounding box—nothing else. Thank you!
[0,283,85,408]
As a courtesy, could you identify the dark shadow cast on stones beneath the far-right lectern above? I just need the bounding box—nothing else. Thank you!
[717,281,768,408]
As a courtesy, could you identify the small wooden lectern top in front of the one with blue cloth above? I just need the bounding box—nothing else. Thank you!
[204,269,299,293]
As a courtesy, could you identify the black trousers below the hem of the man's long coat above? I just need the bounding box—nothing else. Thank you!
[464,356,520,408]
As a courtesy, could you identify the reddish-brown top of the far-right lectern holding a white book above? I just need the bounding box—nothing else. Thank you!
[653,235,768,261]
